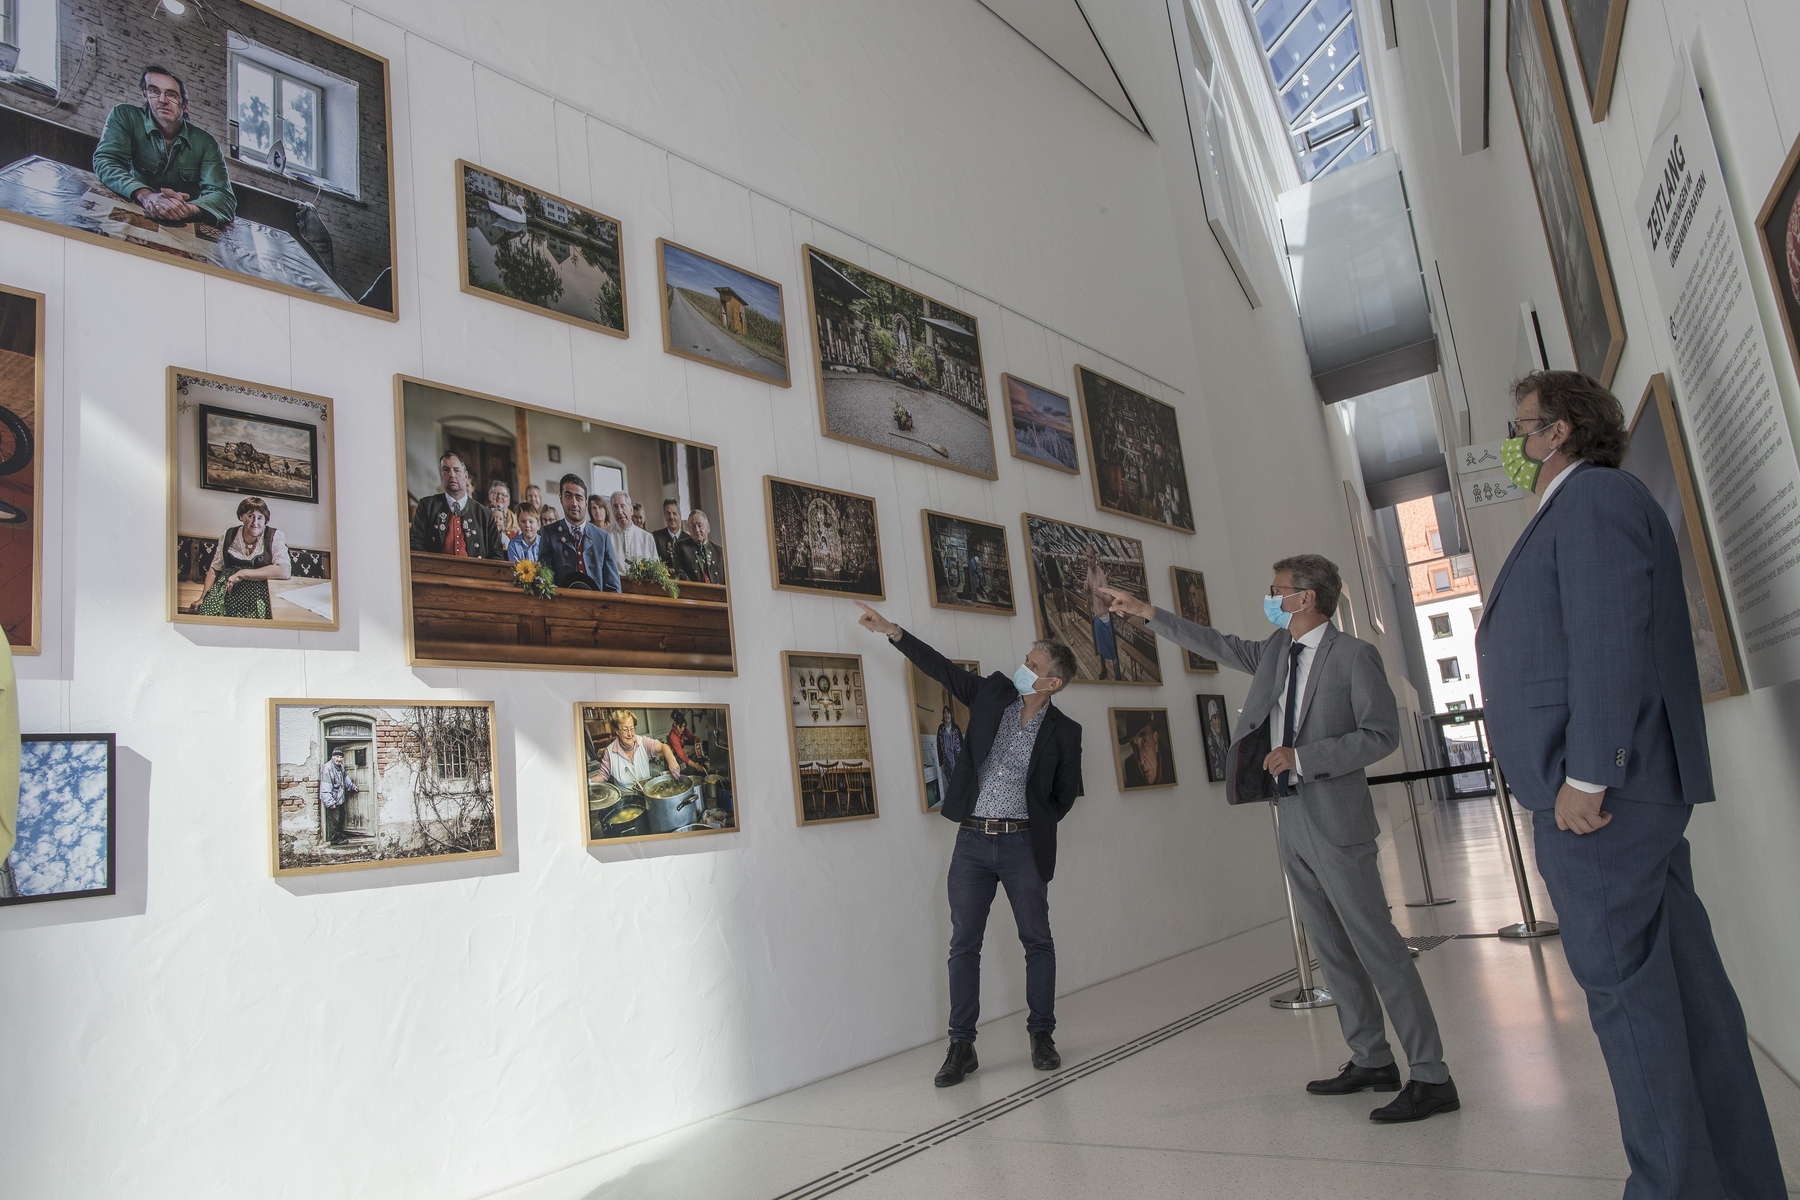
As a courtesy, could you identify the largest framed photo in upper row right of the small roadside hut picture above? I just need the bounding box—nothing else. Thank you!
[803,246,999,479]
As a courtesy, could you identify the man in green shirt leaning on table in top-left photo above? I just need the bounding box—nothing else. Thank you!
[94,65,238,225]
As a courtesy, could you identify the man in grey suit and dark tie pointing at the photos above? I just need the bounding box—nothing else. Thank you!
[1107,554,1462,1123]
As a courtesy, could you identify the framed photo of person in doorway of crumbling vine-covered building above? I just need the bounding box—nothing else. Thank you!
[268,700,500,874]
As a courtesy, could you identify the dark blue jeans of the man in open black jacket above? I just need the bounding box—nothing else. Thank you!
[950,829,1057,1042]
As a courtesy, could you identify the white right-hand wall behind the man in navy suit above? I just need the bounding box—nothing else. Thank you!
[1368,0,1800,1076]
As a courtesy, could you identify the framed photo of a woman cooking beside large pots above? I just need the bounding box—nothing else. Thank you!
[574,702,738,846]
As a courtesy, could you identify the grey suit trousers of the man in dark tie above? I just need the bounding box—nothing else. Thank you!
[1276,791,1451,1083]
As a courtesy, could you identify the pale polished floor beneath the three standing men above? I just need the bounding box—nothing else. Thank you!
[493,801,1800,1200]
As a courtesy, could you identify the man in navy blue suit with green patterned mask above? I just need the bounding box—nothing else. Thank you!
[1476,371,1787,1200]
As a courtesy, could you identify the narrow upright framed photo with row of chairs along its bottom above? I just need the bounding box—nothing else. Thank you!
[781,649,880,826]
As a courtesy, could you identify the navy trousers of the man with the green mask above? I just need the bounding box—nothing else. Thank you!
[1532,793,1787,1200]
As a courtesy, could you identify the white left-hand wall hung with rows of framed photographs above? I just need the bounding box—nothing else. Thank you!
[0,0,1375,1200]
